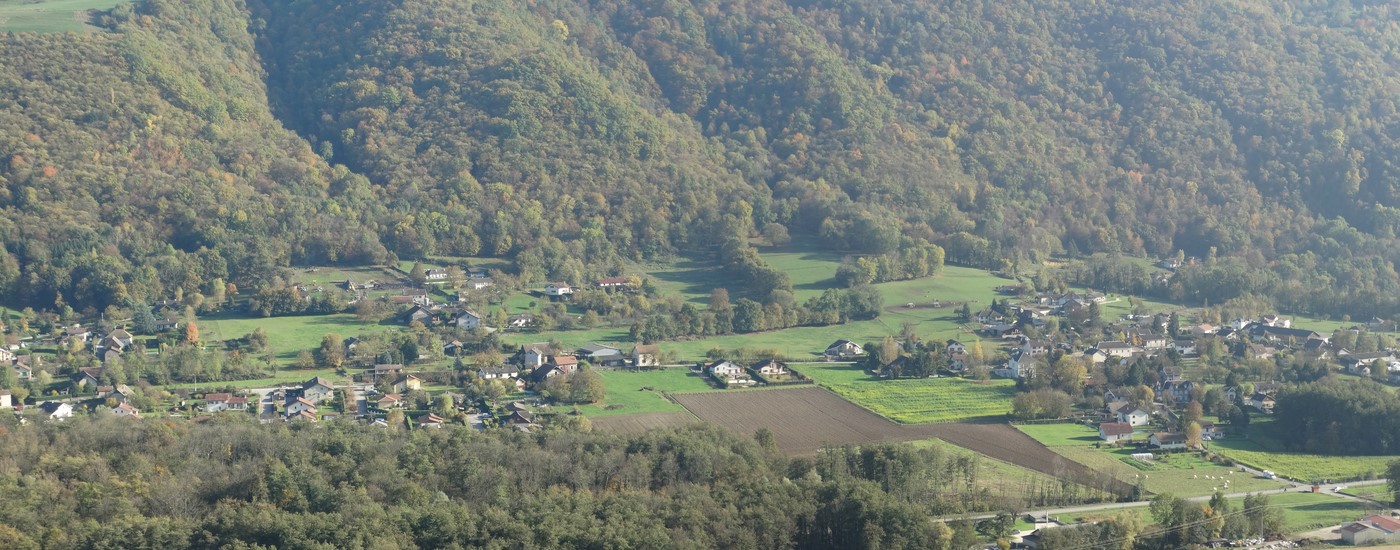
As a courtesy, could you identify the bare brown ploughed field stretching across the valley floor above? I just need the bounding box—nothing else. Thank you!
[673,386,1133,495]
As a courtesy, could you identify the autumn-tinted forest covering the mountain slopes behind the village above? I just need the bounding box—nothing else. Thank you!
[0,0,1400,315]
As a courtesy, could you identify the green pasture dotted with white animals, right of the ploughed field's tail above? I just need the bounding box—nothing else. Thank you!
[1016,424,1284,497]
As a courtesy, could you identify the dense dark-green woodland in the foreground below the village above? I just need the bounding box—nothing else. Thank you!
[0,416,1074,550]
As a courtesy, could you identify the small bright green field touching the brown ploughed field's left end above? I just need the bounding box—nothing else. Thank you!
[578,368,714,417]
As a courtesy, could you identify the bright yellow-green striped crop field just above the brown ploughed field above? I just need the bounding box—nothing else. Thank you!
[792,364,1015,424]
